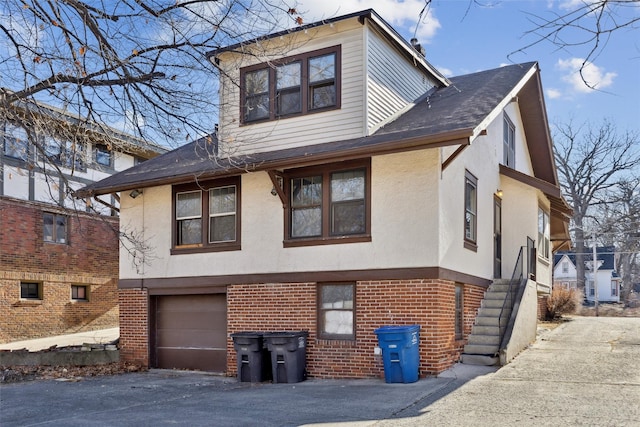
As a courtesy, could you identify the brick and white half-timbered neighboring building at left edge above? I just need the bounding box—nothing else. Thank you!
[0,101,166,343]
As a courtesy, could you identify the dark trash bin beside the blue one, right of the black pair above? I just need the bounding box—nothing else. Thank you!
[264,331,309,383]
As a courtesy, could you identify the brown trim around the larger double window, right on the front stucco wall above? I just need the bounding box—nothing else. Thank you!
[283,159,371,248]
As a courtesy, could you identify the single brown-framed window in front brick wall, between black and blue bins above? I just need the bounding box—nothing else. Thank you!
[318,283,356,340]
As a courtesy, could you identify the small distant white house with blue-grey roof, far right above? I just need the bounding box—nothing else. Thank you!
[553,246,621,302]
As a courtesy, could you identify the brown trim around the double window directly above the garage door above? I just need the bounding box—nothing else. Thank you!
[170,176,242,255]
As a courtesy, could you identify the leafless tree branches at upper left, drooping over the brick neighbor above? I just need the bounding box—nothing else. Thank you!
[0,0,302,265]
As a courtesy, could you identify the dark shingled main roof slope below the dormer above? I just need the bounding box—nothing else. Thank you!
[77,62,537,197]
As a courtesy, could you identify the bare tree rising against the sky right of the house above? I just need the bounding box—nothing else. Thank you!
[554,120,640,289]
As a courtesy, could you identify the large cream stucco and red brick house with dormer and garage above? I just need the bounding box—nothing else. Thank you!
[80,10,570,377]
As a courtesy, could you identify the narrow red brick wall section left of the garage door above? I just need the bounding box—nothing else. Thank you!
[118,289,149,366]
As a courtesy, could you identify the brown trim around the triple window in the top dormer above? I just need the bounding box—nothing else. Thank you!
[240,45,342,125]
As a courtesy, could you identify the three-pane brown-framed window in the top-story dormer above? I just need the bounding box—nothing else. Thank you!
[240,46,341,123]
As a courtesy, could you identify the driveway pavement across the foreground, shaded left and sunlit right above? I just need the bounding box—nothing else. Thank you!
[0,317,640,427]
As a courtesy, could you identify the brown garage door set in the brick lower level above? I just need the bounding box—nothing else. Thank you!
[155,294,227,372]
